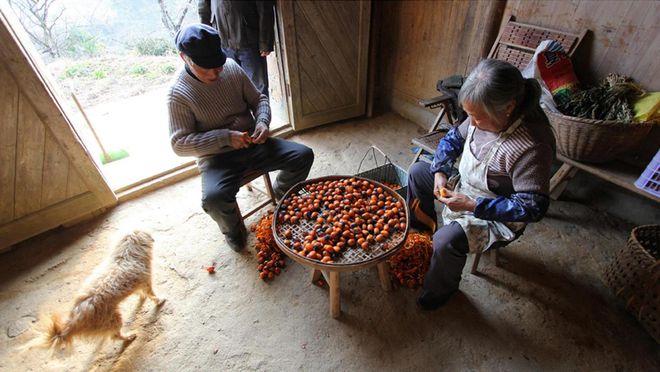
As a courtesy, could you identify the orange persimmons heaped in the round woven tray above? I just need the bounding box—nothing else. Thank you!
[277,178,406,263]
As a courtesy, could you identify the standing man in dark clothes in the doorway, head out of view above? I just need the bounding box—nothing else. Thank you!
[198,0,275,96]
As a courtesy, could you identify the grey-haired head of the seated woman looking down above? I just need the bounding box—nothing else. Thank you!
[458,59,541,132]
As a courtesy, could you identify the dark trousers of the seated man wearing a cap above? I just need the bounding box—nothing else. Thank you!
[199,138,314,235]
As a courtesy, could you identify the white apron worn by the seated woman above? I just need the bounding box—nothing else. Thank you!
[442,119,526,253]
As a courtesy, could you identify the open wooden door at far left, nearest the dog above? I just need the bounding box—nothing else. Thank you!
[0,2,117,252]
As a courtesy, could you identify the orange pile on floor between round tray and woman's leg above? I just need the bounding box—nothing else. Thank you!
[389,233,433,289]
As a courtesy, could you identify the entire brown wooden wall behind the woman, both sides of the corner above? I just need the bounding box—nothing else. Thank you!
[377,0,660,127]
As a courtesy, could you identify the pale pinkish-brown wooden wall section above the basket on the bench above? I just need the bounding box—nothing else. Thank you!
[504,0,660,91]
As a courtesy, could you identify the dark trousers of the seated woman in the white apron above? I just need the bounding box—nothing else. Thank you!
[407,162,469,296]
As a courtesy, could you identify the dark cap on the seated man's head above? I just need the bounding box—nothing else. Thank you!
[174,23,227,68]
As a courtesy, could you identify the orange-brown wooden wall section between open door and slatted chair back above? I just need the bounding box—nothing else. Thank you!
[376,0,505,125]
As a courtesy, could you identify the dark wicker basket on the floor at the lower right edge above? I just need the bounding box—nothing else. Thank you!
[605,225,660,343]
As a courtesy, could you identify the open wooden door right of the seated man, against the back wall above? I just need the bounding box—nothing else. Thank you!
[278,1,371,130]
